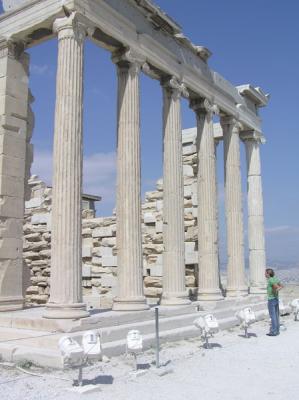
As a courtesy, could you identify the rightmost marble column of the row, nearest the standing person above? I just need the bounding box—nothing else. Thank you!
[241,131,266,294]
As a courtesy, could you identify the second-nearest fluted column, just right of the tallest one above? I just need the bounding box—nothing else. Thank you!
[112,50,149,311]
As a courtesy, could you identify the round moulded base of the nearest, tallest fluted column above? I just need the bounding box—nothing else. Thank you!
[43,303,89,319]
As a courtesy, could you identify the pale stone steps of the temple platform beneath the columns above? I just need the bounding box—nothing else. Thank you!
[0,298,268,368]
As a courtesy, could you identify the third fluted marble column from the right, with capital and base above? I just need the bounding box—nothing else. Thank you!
[191,100,223,300]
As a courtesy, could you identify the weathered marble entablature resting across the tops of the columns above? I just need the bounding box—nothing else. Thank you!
[0,0,268,131]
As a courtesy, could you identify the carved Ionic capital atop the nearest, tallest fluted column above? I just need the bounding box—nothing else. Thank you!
[53,12,89,43]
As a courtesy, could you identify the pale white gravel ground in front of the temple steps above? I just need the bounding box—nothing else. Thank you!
[0,316,299,400]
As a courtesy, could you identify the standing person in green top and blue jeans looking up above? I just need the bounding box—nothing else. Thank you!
[265,268,283,336]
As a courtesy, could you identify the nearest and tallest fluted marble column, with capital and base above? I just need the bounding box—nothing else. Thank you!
[44,13,88,319]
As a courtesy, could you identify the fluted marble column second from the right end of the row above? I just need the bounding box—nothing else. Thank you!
[221,117,248,297]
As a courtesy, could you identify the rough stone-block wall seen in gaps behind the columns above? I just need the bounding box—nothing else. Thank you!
[23,129,198,308]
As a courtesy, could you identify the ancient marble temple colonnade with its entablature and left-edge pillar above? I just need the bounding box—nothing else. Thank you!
[0,0,268,319]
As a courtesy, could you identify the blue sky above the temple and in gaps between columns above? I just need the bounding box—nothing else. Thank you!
[1,0,299,265]
